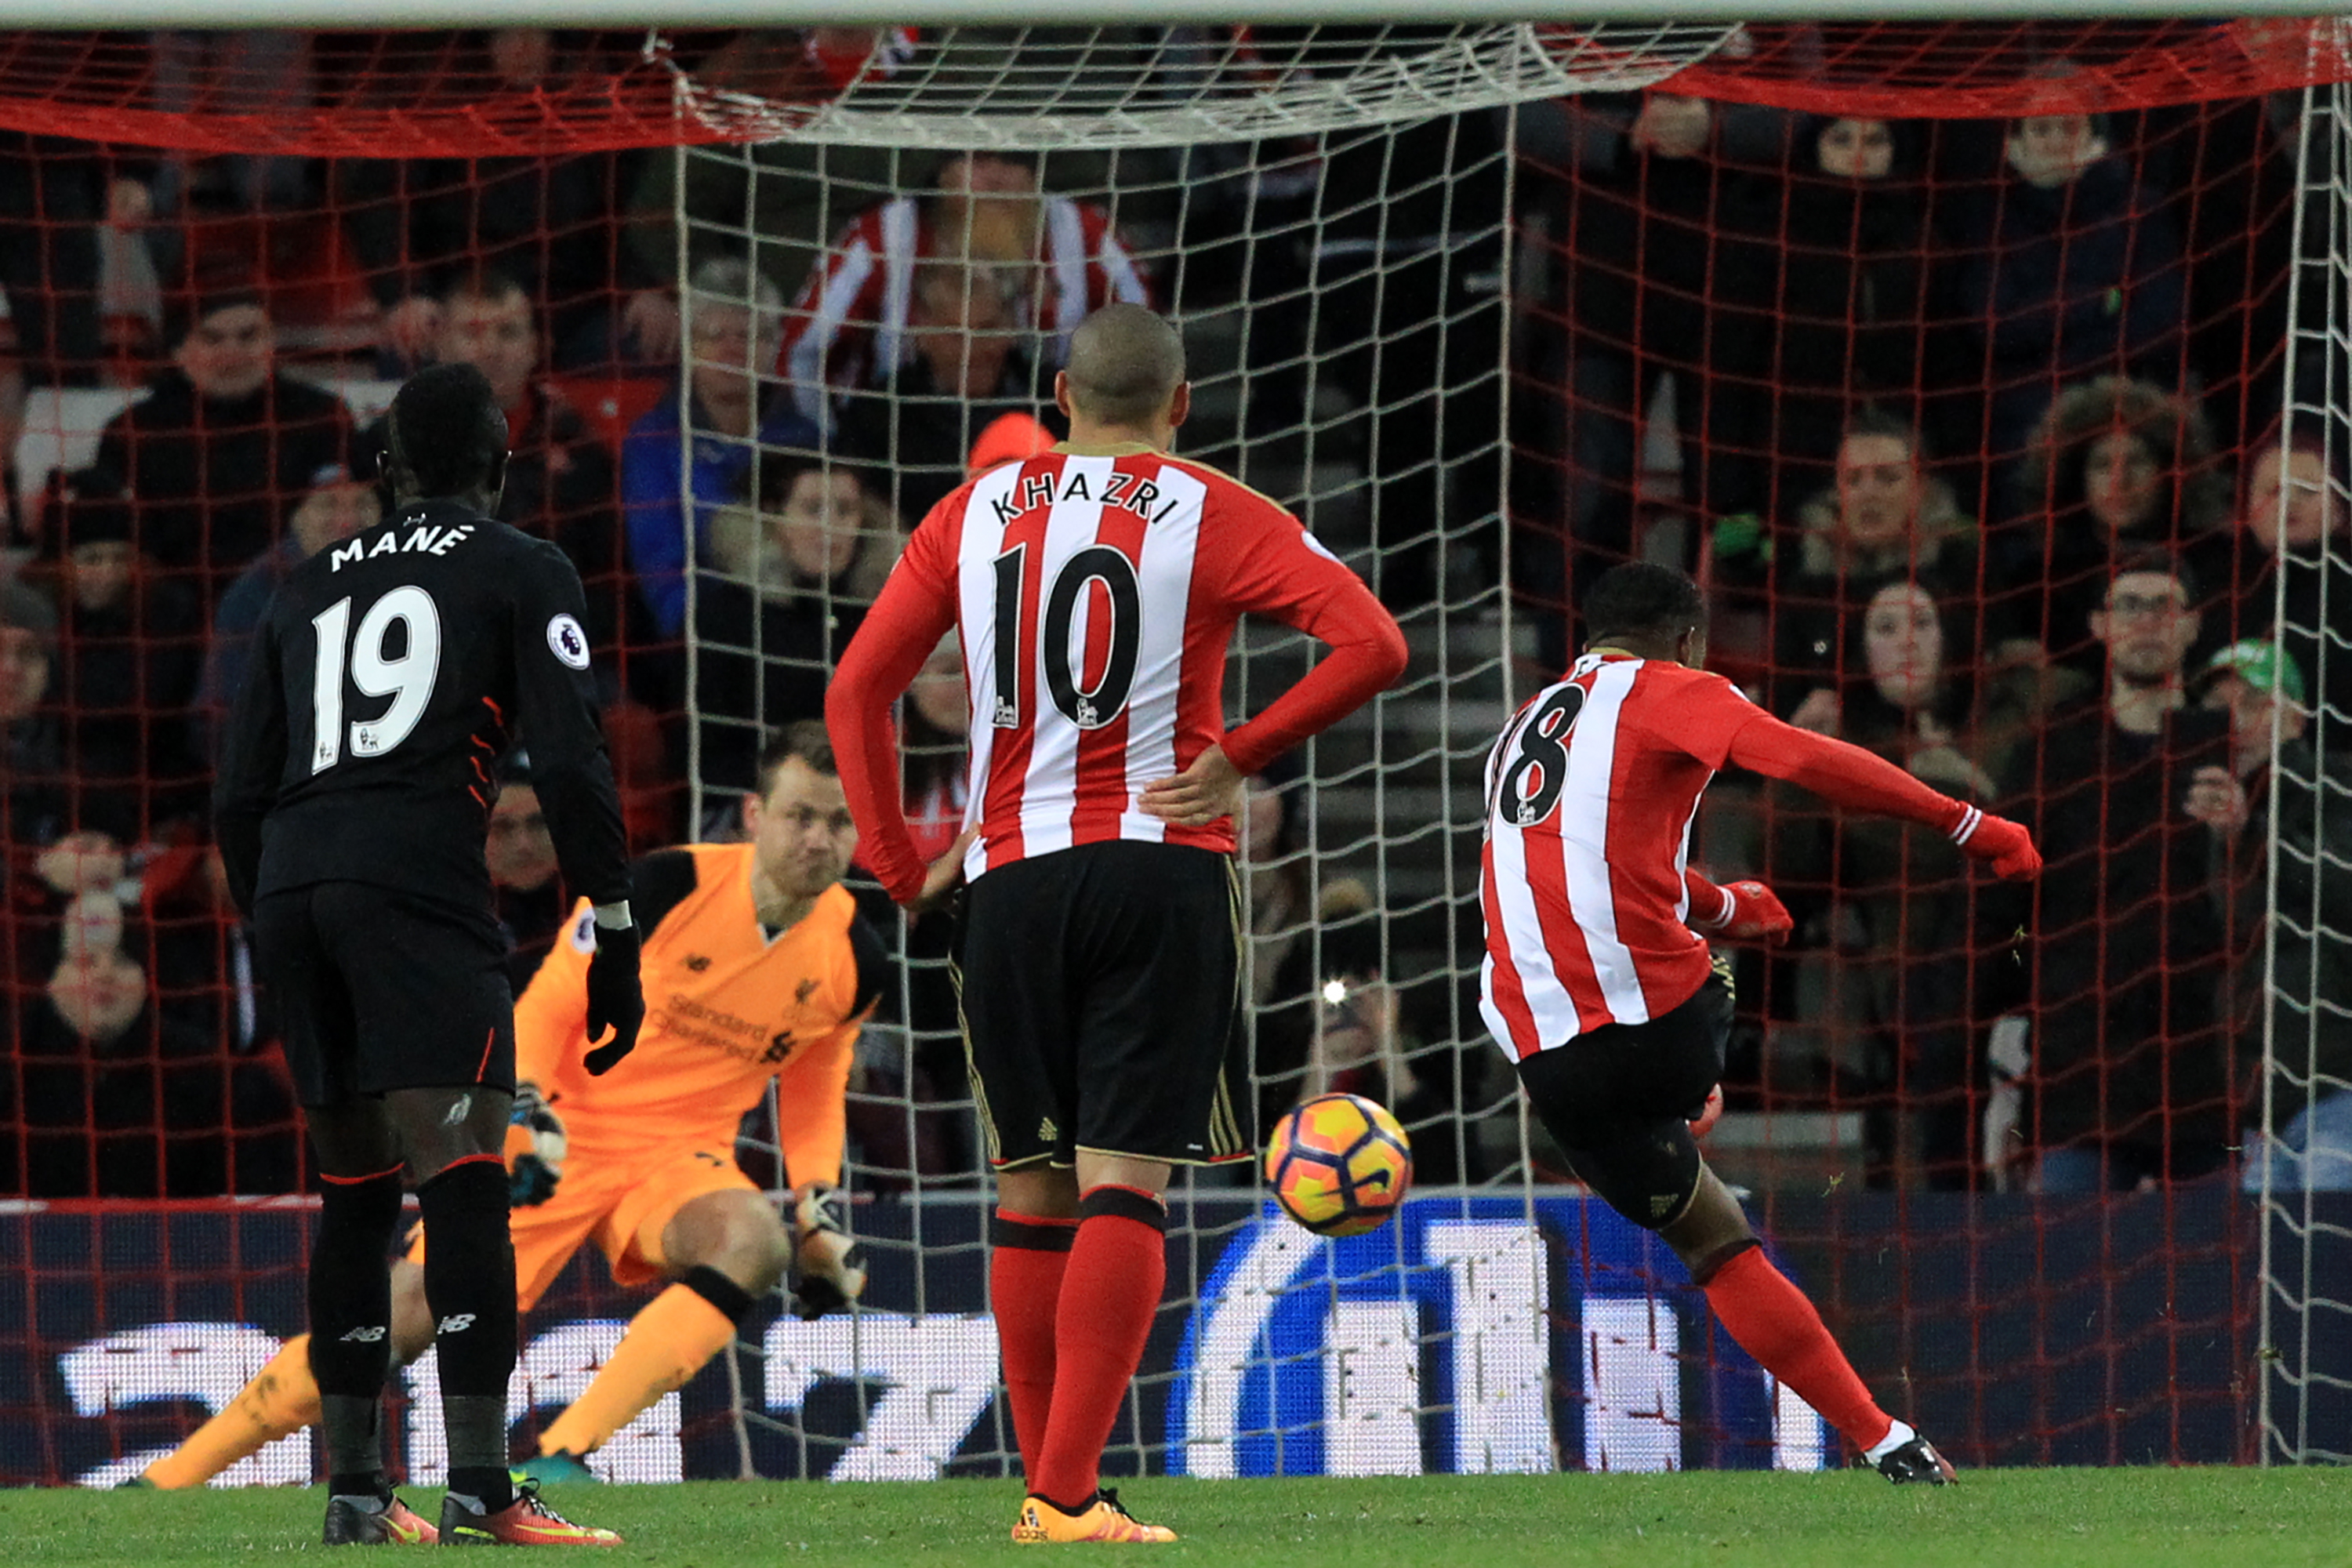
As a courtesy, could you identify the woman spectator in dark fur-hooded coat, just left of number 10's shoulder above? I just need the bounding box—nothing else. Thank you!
[694,456,901,815]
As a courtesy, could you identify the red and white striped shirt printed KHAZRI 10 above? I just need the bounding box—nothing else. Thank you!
[826,445,1404,900]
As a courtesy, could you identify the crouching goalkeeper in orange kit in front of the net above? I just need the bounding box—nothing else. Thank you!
[146,722,884,1488]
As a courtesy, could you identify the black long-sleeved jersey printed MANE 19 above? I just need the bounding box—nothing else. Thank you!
[214,501,628,909]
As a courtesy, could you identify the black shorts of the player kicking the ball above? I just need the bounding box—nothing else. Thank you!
[1519,961,1731,1229]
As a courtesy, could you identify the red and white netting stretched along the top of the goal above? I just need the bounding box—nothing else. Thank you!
[0,16,2352,158]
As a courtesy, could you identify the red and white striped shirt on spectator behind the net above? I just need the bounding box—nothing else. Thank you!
[776,195,1152,428]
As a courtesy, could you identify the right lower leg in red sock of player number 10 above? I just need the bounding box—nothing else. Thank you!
[1030,1185,1167,1512]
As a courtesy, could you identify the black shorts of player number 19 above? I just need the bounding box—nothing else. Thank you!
[254,881,515,1105]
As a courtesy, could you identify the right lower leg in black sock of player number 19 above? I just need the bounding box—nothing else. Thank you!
[416,1154,515,1512]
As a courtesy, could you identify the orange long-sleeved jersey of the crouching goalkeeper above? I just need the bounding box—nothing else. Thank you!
[515,844,884,1185]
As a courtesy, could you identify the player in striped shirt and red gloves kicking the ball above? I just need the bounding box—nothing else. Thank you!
[1479,562,2042,1486]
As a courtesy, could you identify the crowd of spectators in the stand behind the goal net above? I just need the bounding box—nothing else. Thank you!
[0,28,2352,1196]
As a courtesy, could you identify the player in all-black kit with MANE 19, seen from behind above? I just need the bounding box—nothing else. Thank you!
[214,365,644,1547]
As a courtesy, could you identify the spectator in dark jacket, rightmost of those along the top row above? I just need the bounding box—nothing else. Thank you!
[1952,86,2187,463]
